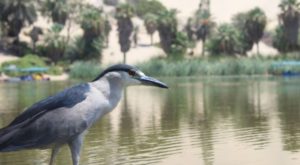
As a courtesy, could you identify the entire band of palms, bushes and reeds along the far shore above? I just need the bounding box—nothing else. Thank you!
[0,0,300,78]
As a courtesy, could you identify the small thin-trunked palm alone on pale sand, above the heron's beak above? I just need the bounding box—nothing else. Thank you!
[144,13,157,45]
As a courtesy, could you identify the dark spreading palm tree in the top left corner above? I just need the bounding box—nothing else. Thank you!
[0,0,37,38]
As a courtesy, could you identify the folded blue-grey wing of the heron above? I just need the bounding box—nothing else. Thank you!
[0,84,89,151]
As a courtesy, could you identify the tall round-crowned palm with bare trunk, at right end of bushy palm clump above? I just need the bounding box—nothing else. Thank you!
[245,8,267,54]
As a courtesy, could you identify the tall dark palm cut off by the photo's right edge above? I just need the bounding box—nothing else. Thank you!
[279,0,300,51]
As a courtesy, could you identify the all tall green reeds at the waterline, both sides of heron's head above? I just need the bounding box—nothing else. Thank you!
[70,57,300,80]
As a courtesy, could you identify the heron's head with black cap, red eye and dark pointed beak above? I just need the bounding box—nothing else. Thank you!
[94,64,168,88]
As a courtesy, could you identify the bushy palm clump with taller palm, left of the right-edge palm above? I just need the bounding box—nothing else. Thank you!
[207,8,267,55]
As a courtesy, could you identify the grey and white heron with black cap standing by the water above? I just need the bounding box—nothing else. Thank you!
[0,64,168,165]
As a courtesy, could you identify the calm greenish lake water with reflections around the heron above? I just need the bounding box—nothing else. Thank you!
[0,77,300,165]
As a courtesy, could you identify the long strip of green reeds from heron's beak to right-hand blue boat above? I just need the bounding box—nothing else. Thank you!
[138,57,275,77]
